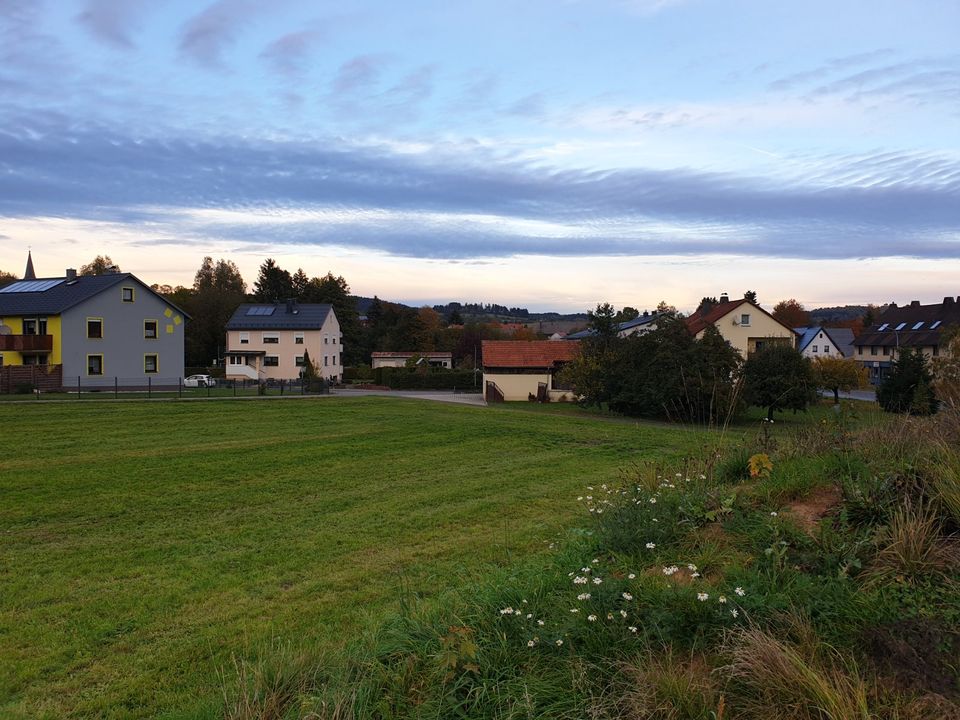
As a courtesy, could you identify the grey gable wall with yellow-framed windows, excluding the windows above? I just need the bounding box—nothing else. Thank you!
[58,278,185,386]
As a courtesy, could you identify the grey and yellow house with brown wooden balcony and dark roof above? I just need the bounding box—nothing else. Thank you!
[0,258,189,390]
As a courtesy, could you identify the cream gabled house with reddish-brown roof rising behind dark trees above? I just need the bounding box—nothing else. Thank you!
[687,295,797,359]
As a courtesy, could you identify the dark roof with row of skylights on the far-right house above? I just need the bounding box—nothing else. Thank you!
[854,297,960,347]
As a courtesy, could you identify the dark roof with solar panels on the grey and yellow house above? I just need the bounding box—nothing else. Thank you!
[0,273,190,318]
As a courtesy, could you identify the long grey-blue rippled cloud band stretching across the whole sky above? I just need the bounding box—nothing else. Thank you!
[0,119,960,259]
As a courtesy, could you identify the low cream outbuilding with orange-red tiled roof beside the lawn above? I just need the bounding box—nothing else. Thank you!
[482,340,580,402]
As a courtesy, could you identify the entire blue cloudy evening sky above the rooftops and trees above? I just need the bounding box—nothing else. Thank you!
[0,0,960,312]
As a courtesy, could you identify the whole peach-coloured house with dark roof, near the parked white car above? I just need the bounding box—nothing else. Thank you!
[224,300,343,382]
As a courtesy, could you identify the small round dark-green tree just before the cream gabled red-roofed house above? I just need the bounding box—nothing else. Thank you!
[743,343,817,420]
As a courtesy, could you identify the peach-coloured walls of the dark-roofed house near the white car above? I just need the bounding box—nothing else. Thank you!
[224,311,343,382]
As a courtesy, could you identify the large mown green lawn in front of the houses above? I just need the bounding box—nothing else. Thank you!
[0,397,715,718]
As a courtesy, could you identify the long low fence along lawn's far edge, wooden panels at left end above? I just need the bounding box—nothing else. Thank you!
[0,376,330,400]
